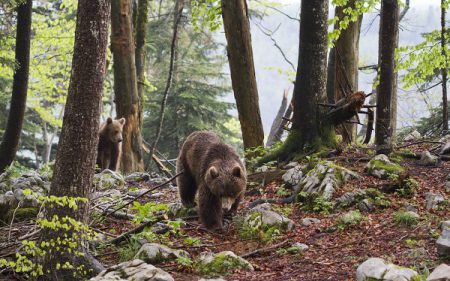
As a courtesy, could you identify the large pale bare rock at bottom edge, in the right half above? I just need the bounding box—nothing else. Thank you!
[356,258,418,281]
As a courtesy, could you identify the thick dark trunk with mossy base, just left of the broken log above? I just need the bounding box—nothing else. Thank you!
[291,0,328,144]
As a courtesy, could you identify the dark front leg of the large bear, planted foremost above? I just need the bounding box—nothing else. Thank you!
[198,186,223,230]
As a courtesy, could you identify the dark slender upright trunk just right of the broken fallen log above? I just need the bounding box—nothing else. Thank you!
[375,0,400,154]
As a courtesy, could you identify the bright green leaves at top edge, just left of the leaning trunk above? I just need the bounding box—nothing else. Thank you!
[191,0,222,32]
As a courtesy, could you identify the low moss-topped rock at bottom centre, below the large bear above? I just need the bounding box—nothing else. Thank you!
[197,251,254,273]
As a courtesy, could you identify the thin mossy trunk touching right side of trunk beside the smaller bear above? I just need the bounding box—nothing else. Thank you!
[136,0,149,129]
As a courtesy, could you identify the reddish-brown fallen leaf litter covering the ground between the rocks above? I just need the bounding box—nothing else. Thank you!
[0,144,450,281]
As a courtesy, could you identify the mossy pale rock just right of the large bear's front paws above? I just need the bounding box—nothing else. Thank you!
[244,203,295,231]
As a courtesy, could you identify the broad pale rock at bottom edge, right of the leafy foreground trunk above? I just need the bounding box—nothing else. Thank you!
[90,259,174,281]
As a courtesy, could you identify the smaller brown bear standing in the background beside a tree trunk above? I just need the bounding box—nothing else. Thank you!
[97,117,125,171]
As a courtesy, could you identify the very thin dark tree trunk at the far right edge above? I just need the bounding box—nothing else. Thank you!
[441,0,448,134]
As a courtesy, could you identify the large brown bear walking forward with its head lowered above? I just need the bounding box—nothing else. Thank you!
[177,131,247,230]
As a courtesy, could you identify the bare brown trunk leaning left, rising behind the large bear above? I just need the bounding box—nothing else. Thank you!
[222,0,264,153]
